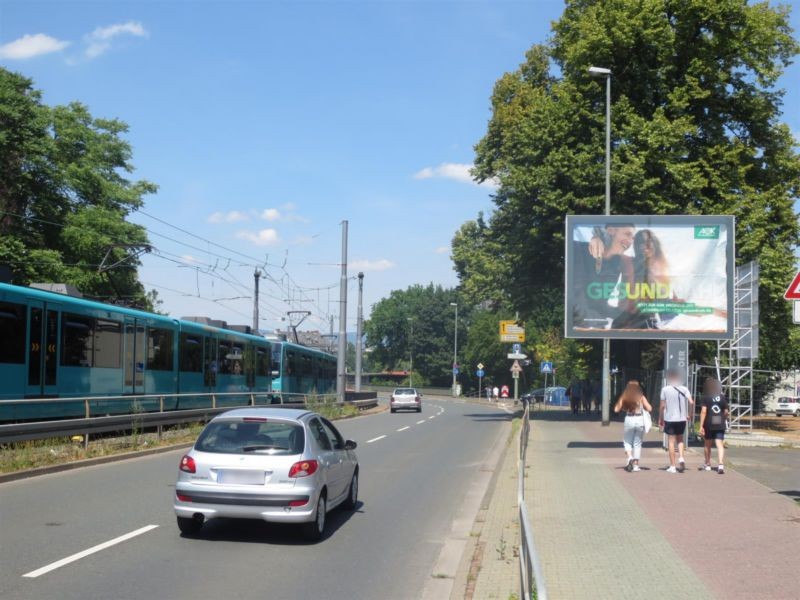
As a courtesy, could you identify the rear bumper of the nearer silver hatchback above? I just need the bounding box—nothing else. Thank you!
[173,488,317,523]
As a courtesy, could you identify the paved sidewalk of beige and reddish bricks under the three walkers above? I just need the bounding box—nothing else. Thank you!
[525,411,800,600]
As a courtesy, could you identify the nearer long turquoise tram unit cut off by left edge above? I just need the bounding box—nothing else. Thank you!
[0,283,273,421]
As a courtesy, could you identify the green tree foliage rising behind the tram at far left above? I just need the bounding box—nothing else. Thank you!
[0,68,156,308]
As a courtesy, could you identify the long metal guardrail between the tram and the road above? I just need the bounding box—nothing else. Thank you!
[0,392,378,446]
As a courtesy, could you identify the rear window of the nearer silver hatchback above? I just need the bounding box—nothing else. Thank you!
[194,420,306,456]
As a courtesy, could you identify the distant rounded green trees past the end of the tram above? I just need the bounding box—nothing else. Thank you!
[364,284,462,386]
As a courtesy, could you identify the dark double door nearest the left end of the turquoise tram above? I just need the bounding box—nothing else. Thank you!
[25,300,61,398]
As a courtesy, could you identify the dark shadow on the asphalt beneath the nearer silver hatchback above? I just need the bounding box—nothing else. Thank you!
[181,500,364,546]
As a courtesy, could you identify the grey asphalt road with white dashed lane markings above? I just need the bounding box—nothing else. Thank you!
[0,400,510,600]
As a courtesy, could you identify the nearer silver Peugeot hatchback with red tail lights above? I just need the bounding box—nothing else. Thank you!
[179,408,358,540]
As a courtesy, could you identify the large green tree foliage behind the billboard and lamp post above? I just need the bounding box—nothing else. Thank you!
[460,0,800,368]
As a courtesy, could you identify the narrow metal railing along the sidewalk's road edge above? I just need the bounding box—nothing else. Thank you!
[517,404,547,600]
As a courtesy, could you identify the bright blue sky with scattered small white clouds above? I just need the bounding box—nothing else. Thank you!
[0,0,800,331]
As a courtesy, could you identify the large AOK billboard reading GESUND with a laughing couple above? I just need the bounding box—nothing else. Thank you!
[564,215,735,340]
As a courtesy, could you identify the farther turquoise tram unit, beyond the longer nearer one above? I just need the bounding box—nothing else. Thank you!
[272,342,336,394]
